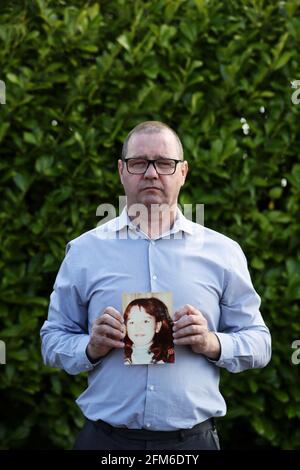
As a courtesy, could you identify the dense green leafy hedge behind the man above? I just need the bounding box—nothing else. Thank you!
[0,0,300,449]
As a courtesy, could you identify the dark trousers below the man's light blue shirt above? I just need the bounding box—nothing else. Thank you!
[74,419,220,450]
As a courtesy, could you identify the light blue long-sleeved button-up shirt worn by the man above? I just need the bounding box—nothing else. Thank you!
[41,209,271,431]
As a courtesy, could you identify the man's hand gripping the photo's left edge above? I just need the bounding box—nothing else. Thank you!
[86,307,126,362]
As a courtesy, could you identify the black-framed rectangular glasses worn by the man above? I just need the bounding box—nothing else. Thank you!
[123,157,183,175]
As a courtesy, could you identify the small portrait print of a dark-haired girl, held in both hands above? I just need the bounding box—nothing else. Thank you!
[123,292,175,365]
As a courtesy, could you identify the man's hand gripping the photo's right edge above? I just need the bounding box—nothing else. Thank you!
[173,304,221,360]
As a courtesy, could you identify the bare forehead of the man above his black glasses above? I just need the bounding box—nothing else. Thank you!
[127,129,178,158]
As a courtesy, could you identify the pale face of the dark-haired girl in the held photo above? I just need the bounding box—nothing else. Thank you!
[127,305,161,346]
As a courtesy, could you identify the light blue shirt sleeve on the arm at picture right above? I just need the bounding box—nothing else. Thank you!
[215,243,271,372]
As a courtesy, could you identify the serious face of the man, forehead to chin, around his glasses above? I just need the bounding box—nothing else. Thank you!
[118,129,188,207]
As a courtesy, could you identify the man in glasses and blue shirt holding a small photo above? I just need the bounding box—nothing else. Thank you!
[41,121,271,450]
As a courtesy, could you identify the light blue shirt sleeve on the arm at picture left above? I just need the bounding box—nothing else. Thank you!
[41,243,98,374]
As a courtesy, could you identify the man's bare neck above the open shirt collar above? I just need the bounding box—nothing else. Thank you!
[128,204,177,239]
